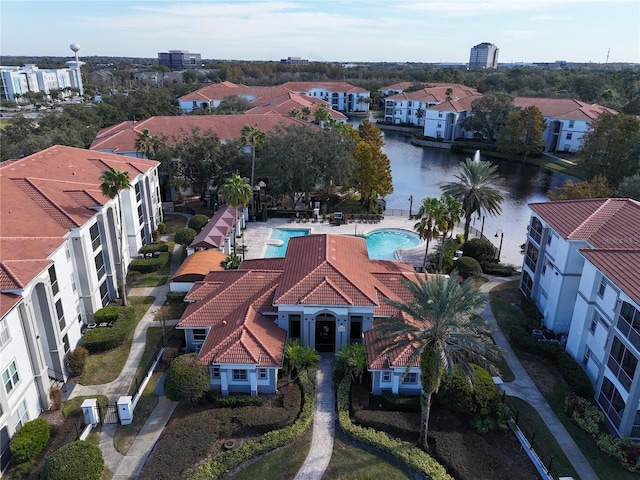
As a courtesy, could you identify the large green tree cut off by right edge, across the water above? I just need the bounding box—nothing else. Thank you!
[579,113,640,187]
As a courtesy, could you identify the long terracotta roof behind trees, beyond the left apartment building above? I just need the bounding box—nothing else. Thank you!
[89,112,308,153]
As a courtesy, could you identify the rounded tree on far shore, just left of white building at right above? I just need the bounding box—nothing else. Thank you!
[497,105,547,161]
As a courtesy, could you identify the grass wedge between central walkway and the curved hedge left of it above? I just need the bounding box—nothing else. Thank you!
[229,428,313,480]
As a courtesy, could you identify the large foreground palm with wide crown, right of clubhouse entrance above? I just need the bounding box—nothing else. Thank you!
[375,271,500,449]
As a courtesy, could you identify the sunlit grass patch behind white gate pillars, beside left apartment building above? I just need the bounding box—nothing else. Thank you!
[79,297,154,385]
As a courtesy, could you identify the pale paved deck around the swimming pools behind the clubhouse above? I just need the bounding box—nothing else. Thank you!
[239,216,430,267]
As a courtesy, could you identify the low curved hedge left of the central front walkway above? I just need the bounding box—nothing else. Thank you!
[189,371,314,480]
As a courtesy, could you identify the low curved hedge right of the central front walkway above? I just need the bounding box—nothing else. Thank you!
[338,378,454,480]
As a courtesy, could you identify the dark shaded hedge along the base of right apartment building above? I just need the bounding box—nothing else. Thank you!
[509,326,594,398]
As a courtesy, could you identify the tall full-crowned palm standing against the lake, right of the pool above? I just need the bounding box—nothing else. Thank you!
[440,158,504,241]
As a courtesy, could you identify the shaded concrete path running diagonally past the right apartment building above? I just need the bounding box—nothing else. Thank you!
[480,277,599,480]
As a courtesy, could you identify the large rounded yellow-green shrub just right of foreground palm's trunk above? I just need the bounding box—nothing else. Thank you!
[437,364,500,417]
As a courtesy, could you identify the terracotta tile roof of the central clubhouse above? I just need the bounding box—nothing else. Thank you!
[178,235,415,366]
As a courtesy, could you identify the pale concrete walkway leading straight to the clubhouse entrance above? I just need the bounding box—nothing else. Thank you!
[294,353,336,480]
